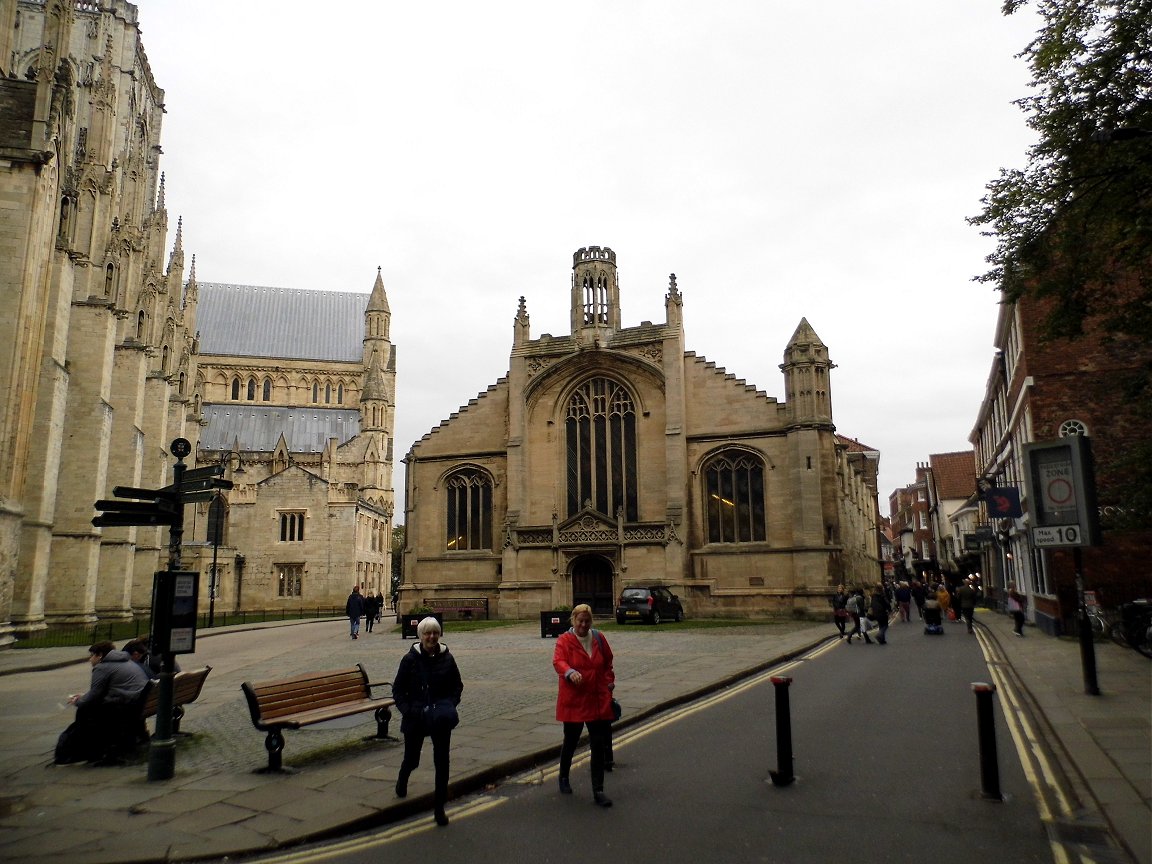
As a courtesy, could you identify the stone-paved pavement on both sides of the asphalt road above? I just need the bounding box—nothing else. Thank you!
[0,612,1152,864]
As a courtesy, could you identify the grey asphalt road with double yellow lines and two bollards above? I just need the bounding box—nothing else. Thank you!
[238,624,1054,864]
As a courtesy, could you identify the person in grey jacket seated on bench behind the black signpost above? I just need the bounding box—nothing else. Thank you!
[56,642,149,763]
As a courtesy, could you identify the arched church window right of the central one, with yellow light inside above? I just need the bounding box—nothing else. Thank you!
[704,450,766,543]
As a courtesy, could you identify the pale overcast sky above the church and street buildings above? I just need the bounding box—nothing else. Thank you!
[139,0,1037,513]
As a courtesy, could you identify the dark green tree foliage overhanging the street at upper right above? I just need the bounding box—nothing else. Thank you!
[969,0,1152,340]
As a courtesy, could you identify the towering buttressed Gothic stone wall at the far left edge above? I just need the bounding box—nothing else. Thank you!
[0,0,188,643]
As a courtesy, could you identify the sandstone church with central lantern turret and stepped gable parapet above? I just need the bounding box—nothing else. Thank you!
[401,247,880,617]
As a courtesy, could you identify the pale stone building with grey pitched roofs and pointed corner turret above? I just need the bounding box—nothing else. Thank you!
[184,278,396,612]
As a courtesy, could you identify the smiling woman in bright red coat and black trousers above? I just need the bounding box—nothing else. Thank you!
[552,604,616,808]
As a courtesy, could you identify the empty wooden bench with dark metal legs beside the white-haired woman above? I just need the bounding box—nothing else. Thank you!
[241,664,396,771]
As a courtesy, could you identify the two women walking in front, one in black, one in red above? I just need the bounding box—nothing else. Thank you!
[392,604,616,826]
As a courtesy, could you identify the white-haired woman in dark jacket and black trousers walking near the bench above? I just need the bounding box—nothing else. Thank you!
[392,615,464,826]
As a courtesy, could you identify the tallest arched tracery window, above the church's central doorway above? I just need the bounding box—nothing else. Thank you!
[564,378,639,522]
